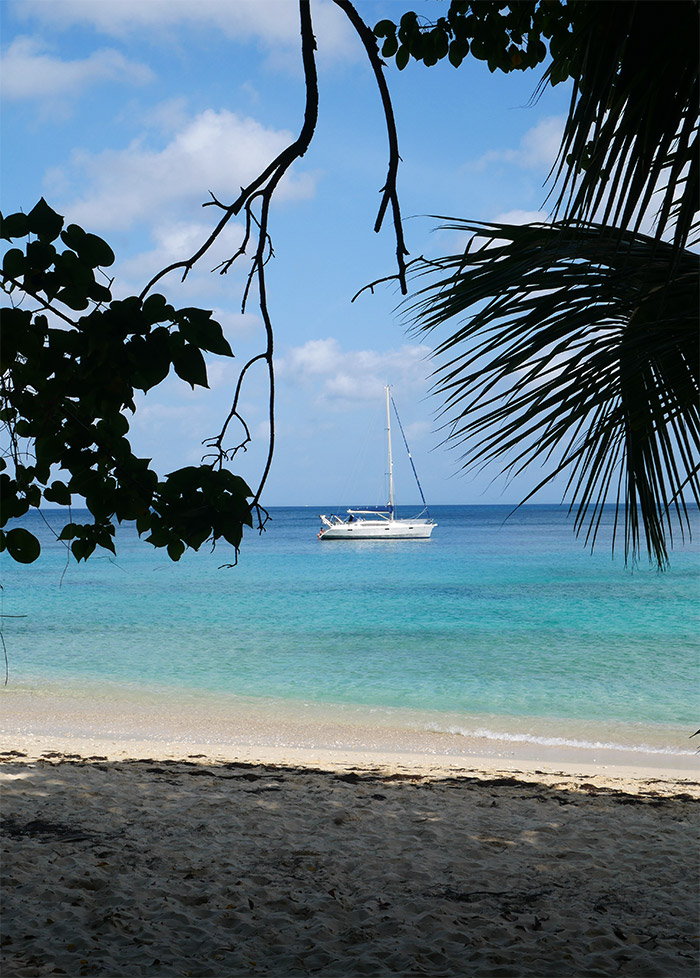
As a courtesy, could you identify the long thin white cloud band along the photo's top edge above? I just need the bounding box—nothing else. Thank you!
[15,0,357,62]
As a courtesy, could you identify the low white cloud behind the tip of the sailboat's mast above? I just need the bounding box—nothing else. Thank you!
[277,339,431,402]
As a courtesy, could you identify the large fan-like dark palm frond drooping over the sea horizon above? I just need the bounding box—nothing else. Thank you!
[405,219,700,567]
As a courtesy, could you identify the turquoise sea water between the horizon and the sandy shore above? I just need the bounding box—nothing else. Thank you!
[0,506,700,743]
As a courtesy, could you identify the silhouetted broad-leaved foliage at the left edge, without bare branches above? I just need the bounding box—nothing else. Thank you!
[0,199,252,563]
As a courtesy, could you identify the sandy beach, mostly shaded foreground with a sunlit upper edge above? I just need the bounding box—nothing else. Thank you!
[0,708,700,978]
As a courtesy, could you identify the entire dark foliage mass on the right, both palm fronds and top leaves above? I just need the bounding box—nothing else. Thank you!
[375,0,700,566]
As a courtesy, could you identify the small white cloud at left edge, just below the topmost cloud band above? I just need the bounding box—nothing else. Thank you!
[0,37,153,100]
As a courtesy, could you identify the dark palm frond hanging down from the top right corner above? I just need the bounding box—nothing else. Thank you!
[541,0,700,248]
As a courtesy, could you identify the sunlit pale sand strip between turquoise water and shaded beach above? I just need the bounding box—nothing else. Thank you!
[0,687,700,795]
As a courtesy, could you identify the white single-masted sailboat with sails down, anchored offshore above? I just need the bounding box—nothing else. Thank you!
[318,386,437,540]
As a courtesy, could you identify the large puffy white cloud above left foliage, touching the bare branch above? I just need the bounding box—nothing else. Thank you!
[51,109,314,231]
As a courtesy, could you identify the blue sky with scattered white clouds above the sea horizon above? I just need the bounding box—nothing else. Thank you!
[0,0,570,506]
